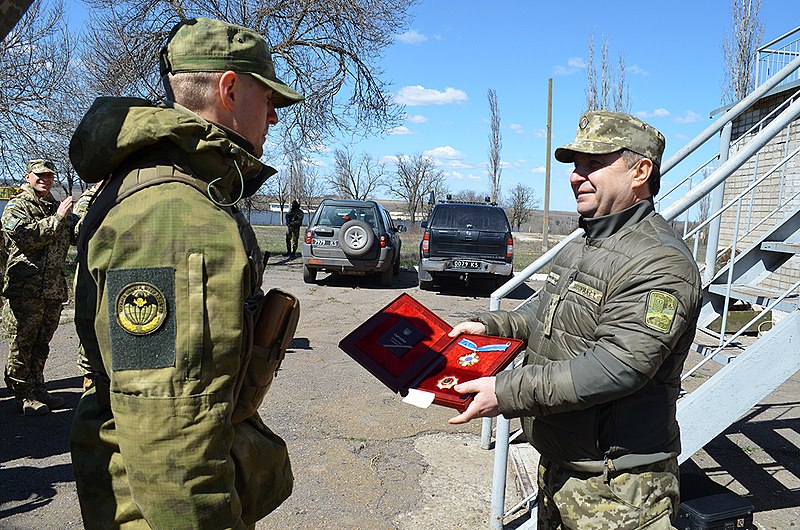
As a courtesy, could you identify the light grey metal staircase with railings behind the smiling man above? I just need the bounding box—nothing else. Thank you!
[481,27,800,529]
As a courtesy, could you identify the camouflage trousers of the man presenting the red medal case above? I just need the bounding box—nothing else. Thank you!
[537,456,679,530]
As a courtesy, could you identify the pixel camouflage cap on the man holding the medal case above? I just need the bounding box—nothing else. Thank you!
[555,110,664,166]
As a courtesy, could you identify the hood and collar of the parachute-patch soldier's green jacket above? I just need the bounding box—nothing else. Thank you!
[69,97,277,197]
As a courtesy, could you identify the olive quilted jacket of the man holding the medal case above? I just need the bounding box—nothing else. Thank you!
[478,201,700,471]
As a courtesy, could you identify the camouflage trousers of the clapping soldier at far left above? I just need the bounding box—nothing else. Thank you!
[2,297,61,397]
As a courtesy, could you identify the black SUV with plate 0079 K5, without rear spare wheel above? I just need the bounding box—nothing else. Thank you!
[419,201,514,290]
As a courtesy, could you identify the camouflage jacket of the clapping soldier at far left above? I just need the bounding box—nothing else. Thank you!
[0,183,77,302]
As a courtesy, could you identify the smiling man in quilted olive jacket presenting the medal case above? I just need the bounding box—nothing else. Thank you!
[450,110,700,530]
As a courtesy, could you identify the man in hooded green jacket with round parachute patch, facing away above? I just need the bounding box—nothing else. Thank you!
[70,18,303,530]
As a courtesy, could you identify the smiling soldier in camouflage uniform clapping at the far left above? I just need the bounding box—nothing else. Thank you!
[0,159,77,416]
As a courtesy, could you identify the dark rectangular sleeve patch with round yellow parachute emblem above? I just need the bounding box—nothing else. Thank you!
[106,267,176,370]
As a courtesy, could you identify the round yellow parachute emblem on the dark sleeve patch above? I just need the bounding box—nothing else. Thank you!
[116,282,167,335]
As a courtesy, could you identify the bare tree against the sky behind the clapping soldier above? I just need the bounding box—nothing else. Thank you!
[0,0,79,185]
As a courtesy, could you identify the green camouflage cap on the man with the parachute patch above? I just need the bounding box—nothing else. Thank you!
[159,18,303,108]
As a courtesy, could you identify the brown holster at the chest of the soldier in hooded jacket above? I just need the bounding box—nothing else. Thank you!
[232,288,300,424]
